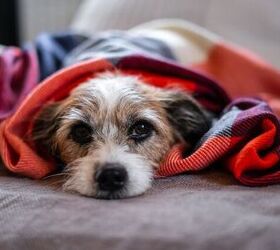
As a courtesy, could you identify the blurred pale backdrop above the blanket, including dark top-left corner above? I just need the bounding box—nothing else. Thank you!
[0,0,280,67]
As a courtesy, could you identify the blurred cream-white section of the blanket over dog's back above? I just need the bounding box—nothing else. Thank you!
[130,19,220,65]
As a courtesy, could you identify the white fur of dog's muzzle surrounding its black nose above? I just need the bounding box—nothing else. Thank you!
[63,144,153,197]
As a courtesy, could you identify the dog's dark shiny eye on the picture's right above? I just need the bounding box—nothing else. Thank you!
[129,121,154,142]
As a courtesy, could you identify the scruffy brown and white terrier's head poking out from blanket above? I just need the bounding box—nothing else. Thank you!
[33,73,210,199]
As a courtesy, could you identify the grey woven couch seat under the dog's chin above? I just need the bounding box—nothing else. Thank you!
[0,169,280,250]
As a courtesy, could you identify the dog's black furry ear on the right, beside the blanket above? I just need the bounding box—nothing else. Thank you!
[159,89,211,146]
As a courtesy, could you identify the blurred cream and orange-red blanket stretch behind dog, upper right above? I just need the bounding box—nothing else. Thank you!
[130,19,280,116]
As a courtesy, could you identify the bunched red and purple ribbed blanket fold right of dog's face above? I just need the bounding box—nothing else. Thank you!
[158,98,280,186]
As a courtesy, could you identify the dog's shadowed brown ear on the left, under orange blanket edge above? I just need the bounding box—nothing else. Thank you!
[31,102,61,155]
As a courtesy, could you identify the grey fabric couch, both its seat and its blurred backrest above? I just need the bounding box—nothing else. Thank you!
[0,0,280,250]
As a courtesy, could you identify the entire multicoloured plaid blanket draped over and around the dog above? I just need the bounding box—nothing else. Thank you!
[0,21,280,186]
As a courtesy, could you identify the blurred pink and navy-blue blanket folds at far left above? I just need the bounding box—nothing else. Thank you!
[0,32,87,122]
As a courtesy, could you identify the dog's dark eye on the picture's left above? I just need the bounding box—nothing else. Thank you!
[70,123,92,145]
